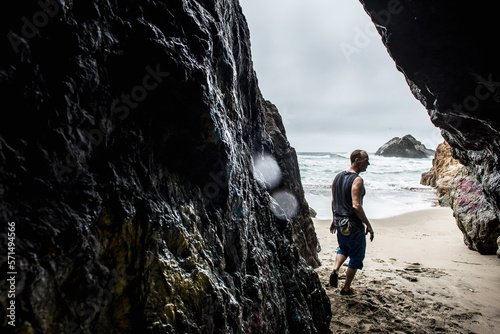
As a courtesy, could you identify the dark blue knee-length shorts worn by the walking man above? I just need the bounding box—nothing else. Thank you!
[337,229,366,269]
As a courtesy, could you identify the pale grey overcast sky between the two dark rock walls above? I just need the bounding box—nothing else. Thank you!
[240,0,443,152]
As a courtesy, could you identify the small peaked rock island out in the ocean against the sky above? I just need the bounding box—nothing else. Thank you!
[375,135,434,158]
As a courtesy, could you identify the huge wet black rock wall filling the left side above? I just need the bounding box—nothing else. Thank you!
[0,0,331,333]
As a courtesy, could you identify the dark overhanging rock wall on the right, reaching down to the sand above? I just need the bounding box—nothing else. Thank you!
[361,0,500,253]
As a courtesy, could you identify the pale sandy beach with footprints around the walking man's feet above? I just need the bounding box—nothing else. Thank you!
[314,208,500,334]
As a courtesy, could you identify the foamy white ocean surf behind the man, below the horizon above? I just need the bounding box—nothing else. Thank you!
[297,152,438,219]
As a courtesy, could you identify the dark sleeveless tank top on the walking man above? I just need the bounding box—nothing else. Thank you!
[332,171,364,229]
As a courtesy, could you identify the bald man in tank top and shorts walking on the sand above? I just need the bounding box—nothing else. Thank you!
[330,150,374,295]
